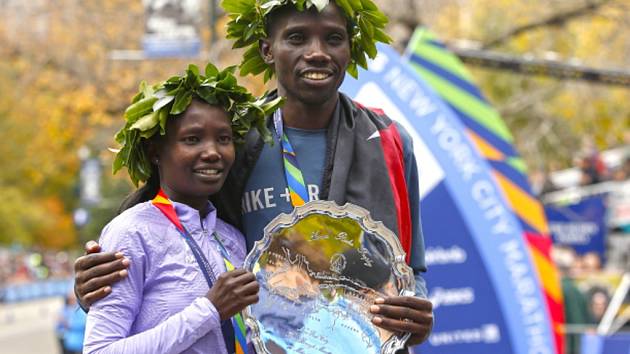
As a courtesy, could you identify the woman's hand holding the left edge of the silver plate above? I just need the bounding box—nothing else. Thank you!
[206,269,259,321]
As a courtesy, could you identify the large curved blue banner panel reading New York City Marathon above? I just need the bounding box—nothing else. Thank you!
[341,46,555,354]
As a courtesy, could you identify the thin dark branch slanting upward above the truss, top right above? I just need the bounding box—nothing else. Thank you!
[482,0,611,49]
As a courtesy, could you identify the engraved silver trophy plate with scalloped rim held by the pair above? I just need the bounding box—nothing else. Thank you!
[244,201,415,354]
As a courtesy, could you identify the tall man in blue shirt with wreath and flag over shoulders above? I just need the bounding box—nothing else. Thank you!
[75,0,433,345]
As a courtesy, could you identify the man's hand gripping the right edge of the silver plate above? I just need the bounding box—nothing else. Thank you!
[370,296,433,345]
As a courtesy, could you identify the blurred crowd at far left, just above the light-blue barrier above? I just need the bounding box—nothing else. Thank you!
[0,247,75,287]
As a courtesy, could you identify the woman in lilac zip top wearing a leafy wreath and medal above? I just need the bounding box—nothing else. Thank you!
[84,64,281,353]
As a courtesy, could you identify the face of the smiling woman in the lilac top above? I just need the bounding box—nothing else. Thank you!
[154,100,234,210]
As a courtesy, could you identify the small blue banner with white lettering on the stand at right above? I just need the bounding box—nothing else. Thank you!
[545,196,606,261]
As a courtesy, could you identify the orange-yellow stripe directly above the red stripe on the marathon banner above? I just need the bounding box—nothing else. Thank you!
[494,171,549,235]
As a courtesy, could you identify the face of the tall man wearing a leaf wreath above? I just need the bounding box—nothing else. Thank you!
[261,3,350,105]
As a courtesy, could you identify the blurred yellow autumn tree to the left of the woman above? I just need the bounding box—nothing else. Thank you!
[0,0,261,248]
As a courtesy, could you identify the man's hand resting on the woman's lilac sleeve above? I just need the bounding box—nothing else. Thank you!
[74,241,129,310]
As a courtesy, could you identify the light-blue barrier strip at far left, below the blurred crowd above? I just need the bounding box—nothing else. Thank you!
[0,279,73,303]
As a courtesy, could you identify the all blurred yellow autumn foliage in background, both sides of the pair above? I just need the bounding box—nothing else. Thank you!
[0,0,630,248]
